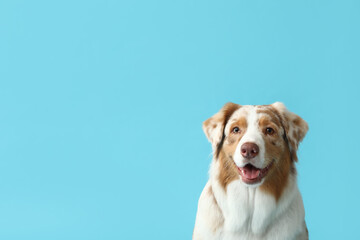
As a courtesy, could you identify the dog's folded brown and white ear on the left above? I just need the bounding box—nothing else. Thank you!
[203,102,241,151]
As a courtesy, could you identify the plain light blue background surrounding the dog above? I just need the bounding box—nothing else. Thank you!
[0,0,360,240]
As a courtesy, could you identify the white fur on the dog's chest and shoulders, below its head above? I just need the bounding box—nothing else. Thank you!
[193,161,307,240]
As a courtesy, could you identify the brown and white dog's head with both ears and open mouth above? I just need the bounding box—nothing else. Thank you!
[203,103,308,192]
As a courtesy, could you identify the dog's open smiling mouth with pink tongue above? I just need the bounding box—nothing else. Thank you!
[237,161,274,184]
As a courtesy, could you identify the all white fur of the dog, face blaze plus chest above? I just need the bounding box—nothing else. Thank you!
[193,106,307,240]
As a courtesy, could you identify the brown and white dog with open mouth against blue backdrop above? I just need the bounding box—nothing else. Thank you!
[193,102,308,240]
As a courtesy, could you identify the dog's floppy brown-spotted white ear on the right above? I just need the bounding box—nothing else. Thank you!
[271,102,309,161]
